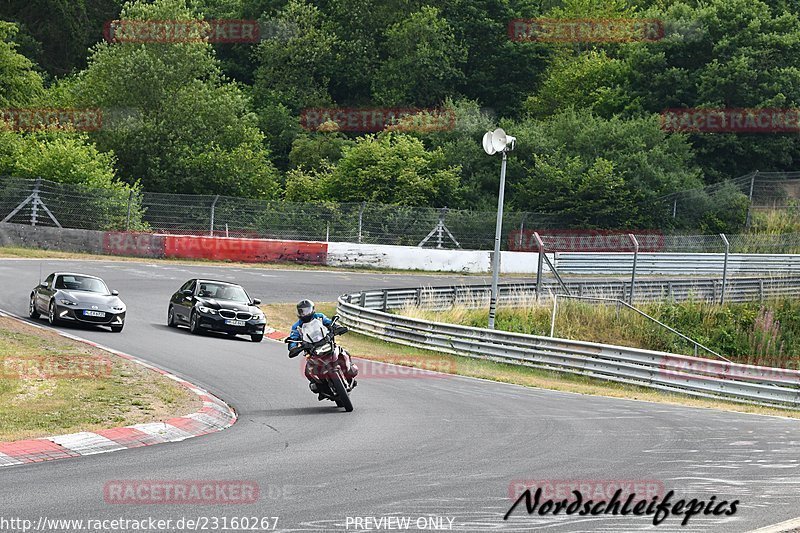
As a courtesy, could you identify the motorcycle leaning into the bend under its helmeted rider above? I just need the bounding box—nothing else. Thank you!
[284,315,355,413]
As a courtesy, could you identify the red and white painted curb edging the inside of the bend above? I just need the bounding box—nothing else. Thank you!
[0,310,237,467]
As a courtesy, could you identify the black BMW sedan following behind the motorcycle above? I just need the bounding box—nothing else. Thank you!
[167,279,267,342]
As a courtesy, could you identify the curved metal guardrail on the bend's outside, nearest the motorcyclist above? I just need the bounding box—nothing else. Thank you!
[338,278,800,409]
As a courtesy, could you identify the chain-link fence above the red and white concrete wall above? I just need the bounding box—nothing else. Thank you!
[0,178,565,249]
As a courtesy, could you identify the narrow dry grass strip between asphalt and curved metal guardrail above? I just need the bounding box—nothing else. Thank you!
[262,303,800,418]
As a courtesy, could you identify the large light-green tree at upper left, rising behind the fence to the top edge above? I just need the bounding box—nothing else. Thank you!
[73,0,278,197]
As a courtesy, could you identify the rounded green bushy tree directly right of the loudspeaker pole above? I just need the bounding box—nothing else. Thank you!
[506,111,700,228]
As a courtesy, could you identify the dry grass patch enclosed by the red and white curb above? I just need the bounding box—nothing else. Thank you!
[0,317,202,441]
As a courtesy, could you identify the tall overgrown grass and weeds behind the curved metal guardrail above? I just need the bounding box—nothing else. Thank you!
[399,298,800,369]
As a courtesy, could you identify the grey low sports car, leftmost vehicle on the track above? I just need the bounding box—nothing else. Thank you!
[28,272,126,332]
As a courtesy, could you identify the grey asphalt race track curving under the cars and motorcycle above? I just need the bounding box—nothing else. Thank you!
[0,260,800,532]
